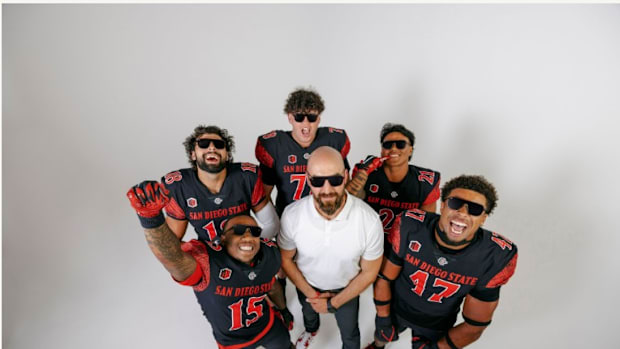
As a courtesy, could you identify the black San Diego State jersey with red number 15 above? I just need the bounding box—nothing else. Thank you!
[182,239,281,348]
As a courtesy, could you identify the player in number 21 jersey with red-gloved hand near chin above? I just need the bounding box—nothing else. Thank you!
[347,123,440,233]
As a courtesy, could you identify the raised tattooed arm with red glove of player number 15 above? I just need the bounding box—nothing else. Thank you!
[127,181,196,280]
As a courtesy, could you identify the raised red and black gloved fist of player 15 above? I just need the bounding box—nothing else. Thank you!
[127,181,170,229]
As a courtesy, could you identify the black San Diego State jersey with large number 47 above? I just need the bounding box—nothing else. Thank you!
[386,209,517,330]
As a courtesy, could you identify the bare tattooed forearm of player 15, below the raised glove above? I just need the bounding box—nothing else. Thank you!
[144,223,196,281]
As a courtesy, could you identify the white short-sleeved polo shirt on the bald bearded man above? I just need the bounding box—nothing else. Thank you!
[278,194,383,290]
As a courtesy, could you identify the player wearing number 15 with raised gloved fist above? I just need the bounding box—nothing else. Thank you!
[127,181,293,349]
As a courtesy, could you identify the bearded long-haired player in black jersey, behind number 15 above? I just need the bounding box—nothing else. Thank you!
[161,125,280,242]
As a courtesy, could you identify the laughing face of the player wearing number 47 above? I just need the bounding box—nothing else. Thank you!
[435,188,488,249]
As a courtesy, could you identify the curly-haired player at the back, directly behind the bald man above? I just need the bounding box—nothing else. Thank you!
[255,89,351,215]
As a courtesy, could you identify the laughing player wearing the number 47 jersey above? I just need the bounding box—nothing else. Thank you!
[367,175,517,349]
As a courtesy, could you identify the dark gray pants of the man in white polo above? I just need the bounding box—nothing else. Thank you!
[297,289,361,349]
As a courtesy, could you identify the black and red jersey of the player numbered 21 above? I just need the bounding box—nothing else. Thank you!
[356,165,440,233]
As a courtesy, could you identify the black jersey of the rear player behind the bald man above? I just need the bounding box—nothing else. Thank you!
[255,127,351,215]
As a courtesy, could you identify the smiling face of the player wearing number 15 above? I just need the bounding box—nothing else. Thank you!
[221,216,260,264]
